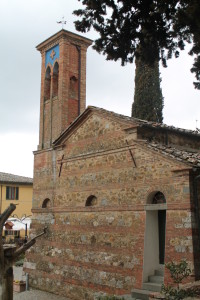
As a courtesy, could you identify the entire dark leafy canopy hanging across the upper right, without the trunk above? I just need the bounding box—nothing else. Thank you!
[74,0,200,89]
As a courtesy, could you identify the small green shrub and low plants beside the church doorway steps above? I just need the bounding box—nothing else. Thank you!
[162,260,199,300]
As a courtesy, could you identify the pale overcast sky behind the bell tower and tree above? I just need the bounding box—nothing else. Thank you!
[0,0,200,177]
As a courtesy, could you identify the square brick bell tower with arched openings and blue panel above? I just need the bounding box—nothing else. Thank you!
[36,29,92,150]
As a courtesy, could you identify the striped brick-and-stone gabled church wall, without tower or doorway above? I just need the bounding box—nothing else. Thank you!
[25,113,197,300]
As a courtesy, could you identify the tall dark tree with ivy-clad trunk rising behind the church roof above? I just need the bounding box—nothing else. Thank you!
[74,0,184,122]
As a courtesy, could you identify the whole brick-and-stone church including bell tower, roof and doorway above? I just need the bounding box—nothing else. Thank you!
[24,30,200,300]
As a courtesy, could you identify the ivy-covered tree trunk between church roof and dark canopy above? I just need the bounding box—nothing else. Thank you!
[132,59,164,123]
